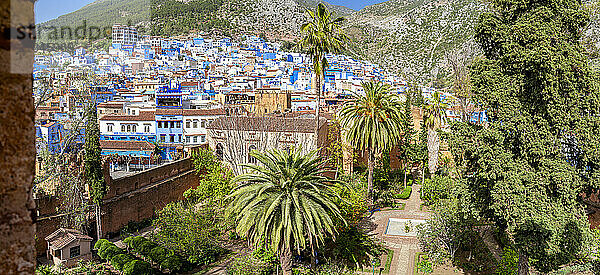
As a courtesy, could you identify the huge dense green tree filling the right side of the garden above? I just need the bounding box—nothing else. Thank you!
[450,0,600,274]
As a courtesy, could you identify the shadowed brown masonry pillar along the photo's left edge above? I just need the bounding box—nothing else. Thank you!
[0,0,35,275]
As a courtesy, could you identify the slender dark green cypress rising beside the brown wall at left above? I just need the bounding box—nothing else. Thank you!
[84,104,108,238]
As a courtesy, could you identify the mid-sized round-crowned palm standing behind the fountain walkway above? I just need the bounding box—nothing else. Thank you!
[338,82,404,205]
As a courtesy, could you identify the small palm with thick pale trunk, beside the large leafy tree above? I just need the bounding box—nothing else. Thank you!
[424,91,448,173]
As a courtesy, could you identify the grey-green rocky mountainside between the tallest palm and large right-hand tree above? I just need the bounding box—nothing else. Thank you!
[347,0,485,83]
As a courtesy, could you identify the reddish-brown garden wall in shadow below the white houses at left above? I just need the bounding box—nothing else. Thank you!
[35,158,198,256]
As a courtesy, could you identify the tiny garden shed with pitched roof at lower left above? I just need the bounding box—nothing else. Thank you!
[46,228,92,267]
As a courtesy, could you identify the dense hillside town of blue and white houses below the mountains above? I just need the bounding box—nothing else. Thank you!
[34,25,486,167]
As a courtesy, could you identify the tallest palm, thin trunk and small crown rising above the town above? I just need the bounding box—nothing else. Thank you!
[298,3,349,137]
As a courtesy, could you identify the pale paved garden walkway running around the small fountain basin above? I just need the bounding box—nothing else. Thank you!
[363,185,430,275]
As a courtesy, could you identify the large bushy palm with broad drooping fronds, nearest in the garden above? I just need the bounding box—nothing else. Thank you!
[229,148,345,274]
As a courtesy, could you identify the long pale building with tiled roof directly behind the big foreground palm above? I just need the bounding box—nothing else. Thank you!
[207,117,328,173]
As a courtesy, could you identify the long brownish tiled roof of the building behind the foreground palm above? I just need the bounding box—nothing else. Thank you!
[207,117,327,133]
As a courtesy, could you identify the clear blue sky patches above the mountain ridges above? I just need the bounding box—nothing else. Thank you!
[35,0,385,23]
